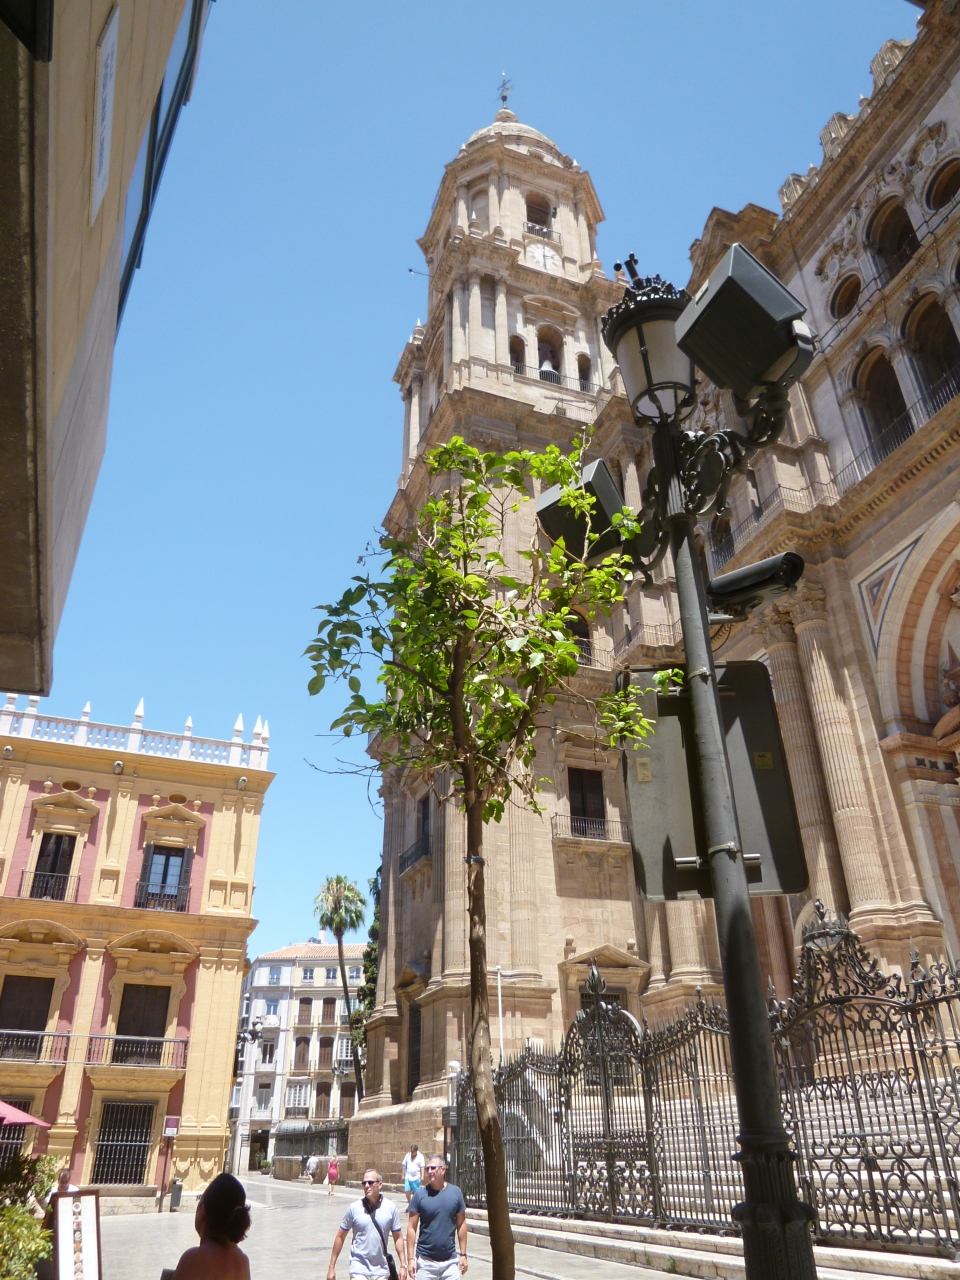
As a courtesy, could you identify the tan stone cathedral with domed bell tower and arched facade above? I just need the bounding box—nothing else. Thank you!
[351,0,960,1167]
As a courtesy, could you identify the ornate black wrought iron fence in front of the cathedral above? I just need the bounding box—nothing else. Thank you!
[456,904,960,1257]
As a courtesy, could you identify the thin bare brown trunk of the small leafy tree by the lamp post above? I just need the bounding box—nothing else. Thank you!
[467,800,515,1280]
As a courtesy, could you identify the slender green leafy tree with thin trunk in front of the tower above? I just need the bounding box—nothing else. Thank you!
[307,438,665,1280]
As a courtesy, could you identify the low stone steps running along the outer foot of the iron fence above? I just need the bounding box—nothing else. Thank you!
[467,1208,960,1280]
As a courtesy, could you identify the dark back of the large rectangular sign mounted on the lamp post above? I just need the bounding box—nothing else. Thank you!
[623,662,809,902]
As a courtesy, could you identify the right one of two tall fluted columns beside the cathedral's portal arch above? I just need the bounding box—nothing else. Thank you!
[787,581,890,922]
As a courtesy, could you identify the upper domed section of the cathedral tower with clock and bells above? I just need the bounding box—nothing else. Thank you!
[394,106,620,477]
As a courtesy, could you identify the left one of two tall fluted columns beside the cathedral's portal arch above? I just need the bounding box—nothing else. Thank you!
[754,605,850,914]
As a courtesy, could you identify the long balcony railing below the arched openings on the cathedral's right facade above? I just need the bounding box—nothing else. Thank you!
[708,367,960,573]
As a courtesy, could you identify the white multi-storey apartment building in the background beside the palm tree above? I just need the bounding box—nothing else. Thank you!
[229,937,364,1175]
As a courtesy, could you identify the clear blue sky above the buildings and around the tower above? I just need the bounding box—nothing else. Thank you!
[45,0,918,954]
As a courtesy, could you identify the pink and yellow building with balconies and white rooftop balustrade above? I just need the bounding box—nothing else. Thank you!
[0,694,273,1189]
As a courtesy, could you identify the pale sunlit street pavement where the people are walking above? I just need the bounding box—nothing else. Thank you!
[100,1174,664,1280]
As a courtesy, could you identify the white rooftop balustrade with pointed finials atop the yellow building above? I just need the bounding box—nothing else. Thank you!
[0,694,270,769]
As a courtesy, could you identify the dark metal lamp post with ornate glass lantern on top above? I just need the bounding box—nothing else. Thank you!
[604,264,817,1280]
